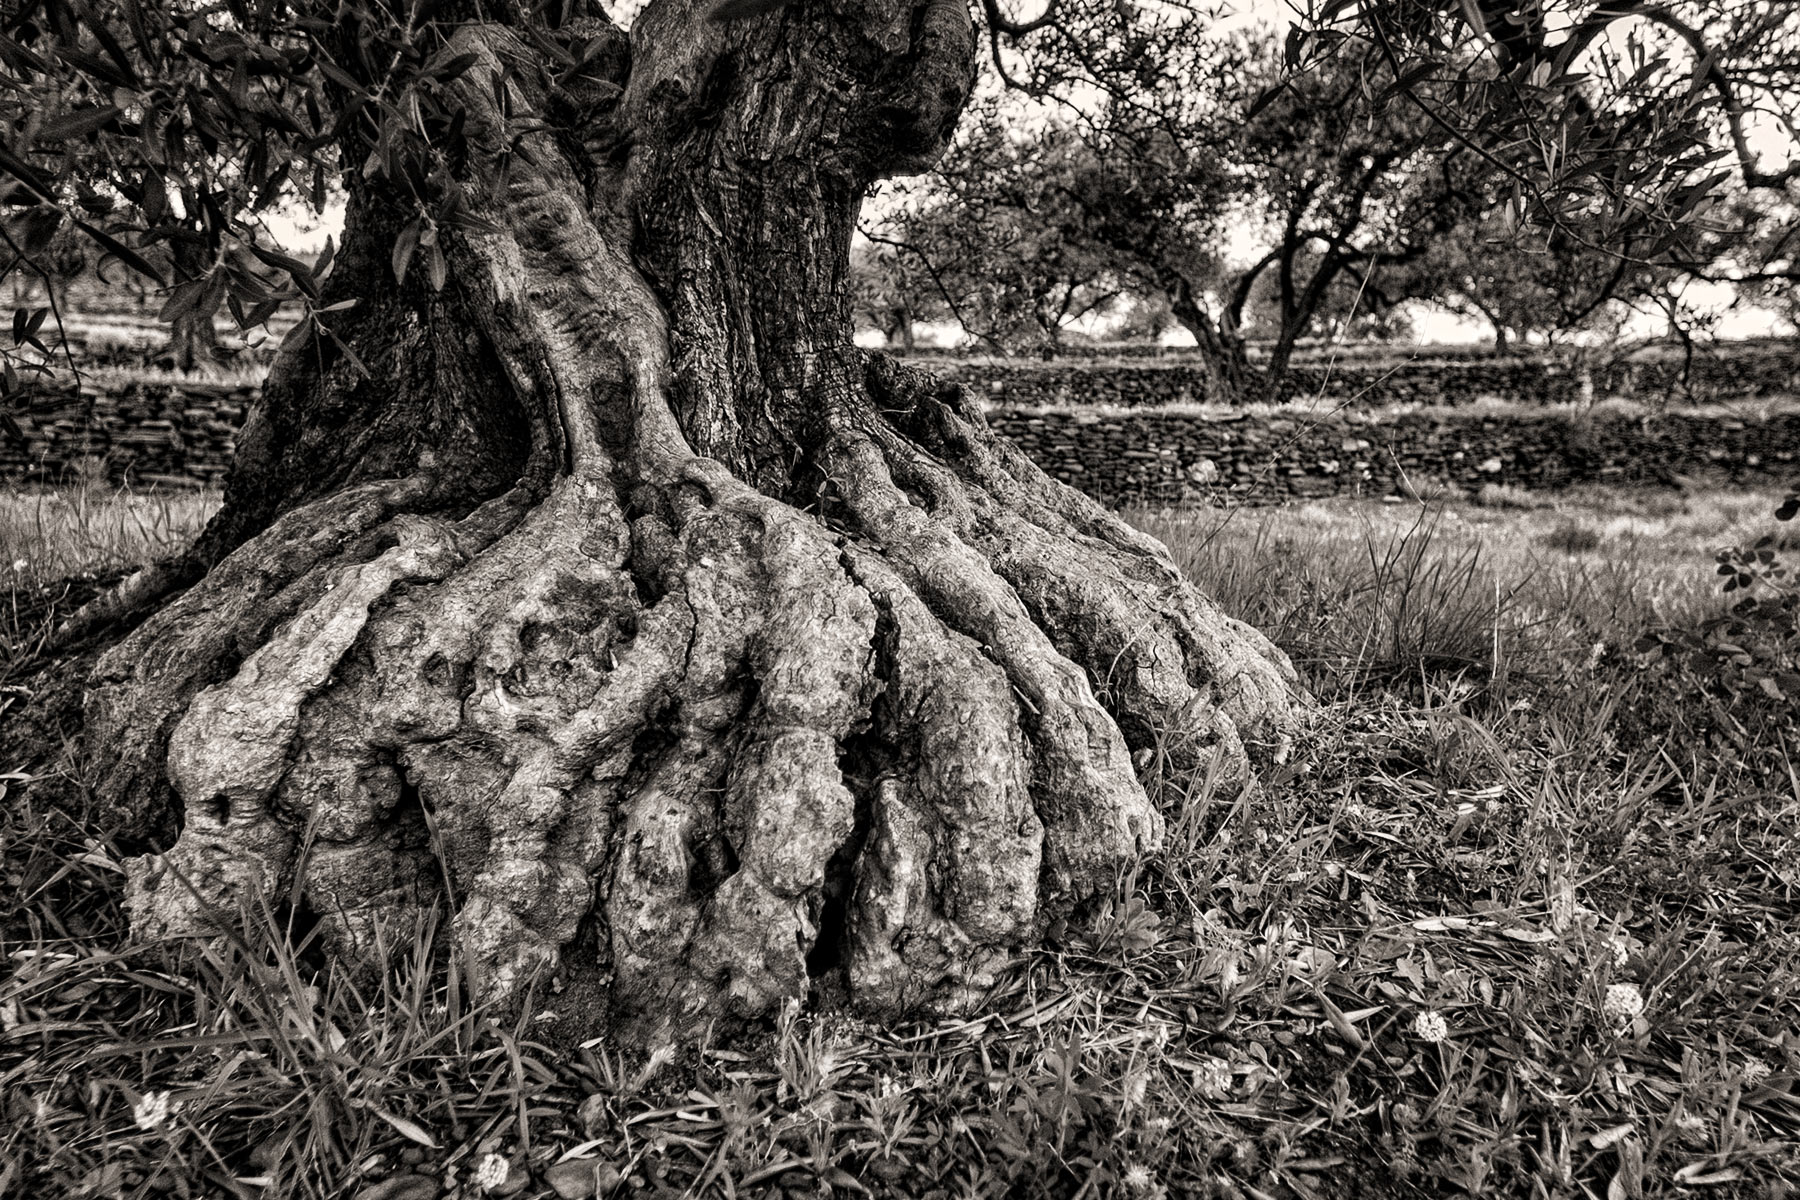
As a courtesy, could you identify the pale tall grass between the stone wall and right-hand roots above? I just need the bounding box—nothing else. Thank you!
[1136,489,1780,694]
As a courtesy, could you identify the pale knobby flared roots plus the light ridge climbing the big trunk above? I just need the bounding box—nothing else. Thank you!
[86,27,1300,1043]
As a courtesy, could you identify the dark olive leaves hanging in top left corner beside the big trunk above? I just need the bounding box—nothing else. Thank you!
[0,0,621,395]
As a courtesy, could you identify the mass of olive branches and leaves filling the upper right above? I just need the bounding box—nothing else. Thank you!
[864,2,1796,372]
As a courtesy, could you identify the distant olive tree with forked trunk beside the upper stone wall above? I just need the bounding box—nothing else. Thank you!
[913,36,1490,396]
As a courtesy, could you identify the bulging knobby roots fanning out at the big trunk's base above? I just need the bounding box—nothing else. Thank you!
[94,429,1291,1042]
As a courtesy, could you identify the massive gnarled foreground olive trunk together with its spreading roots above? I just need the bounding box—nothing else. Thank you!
[86,0,1300,1043]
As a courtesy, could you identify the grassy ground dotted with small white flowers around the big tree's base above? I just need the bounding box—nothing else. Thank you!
[0,489,1800,1200]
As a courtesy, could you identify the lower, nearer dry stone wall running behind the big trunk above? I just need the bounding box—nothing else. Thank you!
[0,367,1800,504]
